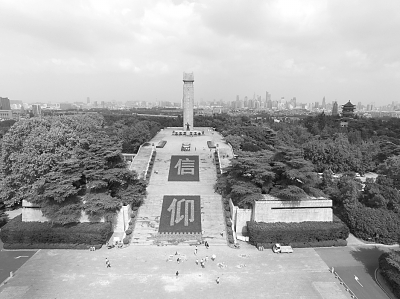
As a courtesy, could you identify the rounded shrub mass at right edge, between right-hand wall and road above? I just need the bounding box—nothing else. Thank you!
[340,205,400,244]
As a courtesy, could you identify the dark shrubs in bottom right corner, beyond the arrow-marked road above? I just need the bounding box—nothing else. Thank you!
[379,251,400,298]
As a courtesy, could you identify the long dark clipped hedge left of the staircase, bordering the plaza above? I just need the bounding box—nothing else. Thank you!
[0,215,112,248]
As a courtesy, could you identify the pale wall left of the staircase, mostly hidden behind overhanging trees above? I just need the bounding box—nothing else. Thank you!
[22,200,132,232]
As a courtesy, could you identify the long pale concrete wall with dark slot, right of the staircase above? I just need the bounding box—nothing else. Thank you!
[252,199,333,222]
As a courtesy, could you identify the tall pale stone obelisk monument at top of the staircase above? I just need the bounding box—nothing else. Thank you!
[182,73,194,131]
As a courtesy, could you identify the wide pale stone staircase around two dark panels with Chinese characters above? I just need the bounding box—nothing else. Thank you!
[131,130,227,246]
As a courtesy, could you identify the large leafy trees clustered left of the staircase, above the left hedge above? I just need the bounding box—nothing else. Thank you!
[0,114,146,224]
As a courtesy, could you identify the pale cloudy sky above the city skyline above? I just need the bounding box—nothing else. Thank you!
[0,0,400,106]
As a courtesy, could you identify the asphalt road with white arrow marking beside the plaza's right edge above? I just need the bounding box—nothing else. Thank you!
[315,246,389,299]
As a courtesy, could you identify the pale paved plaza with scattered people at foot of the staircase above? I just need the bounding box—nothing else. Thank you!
[0,246,350,299]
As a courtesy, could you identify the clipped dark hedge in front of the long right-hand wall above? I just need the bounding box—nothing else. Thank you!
[247,217,349,245]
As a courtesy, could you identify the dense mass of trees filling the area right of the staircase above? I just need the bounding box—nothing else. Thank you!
[209,113,400,243]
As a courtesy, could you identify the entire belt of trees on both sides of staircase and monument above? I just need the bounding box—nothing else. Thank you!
[0,113,400,243]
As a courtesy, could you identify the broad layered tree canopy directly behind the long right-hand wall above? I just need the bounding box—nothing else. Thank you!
[216,147,324,207]
